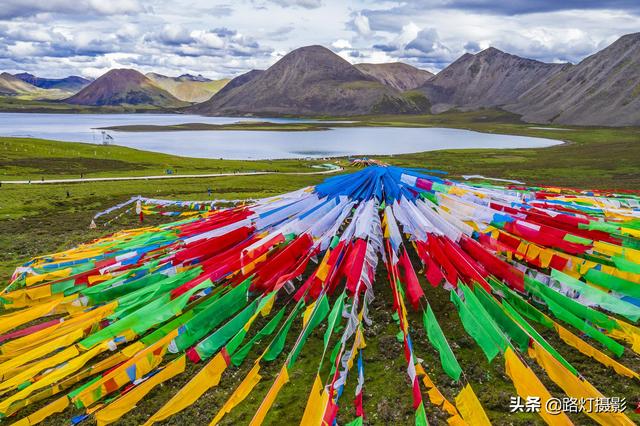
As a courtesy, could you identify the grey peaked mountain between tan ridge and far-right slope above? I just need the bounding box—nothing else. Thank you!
[419,47,570,112]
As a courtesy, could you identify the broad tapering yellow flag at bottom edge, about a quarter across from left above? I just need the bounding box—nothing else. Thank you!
[145,352,227,425]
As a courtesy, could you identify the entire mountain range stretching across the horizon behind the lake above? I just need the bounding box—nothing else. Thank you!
[0,33,640,126]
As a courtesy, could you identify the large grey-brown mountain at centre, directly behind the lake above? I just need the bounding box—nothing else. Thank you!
[189,46,428,115]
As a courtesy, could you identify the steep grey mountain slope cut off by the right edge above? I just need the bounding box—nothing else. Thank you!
[506,33,640,126]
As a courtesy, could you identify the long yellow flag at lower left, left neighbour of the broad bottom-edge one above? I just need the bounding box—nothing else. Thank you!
[95,355,186,426]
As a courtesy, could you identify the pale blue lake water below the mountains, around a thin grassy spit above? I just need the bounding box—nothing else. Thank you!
[0,113,561,160]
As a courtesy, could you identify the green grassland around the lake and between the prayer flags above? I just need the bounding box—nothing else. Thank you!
[0,110,640,425]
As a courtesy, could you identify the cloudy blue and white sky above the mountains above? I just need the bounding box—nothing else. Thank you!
[0,0,640,78]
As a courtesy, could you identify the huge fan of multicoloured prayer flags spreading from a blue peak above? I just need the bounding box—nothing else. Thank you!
[0,166,640,425]
